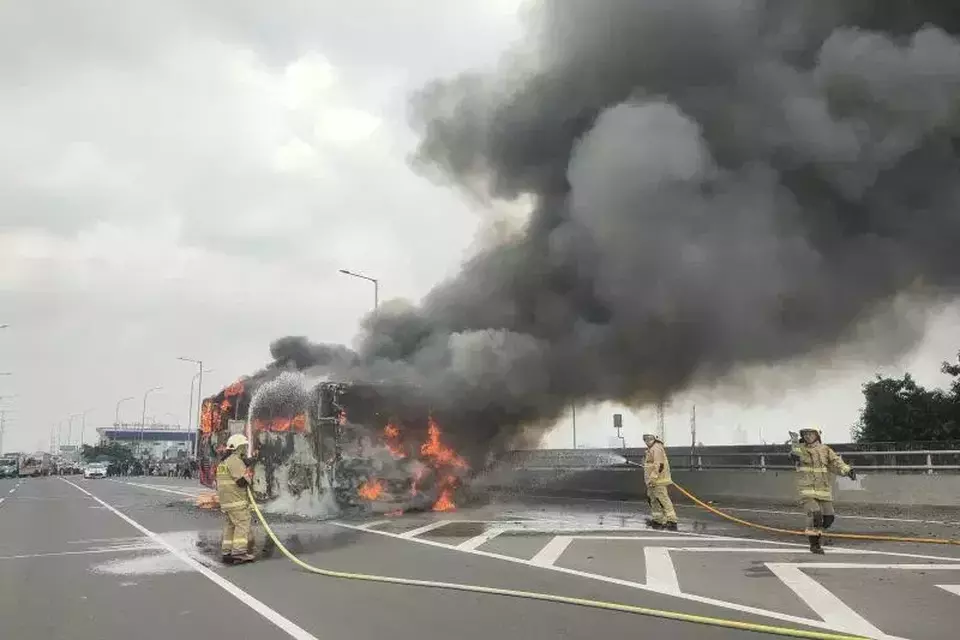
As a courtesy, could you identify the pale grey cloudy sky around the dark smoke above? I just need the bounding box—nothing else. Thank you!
[0,0,957,450]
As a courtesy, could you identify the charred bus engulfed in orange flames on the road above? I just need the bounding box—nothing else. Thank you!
[198,372,470,514]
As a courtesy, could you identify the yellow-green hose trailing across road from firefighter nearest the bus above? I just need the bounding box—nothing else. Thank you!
[247,487,866,640]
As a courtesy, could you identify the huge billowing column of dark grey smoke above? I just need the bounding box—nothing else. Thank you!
[273,0,960,460]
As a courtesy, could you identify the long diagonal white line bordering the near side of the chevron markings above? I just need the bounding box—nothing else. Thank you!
[331,522,852,631]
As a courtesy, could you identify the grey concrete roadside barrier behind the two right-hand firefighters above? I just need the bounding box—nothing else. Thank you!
[483,467,960,507]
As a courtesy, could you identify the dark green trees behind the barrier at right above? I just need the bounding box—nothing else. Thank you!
[853,354,960,442]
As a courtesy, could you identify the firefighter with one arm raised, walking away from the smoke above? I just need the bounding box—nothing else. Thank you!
[790,429,857,554]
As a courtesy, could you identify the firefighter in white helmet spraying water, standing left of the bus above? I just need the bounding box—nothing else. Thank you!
[217,433,256,564]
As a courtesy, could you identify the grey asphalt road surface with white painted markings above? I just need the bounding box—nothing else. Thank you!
[0,477,960,640]
